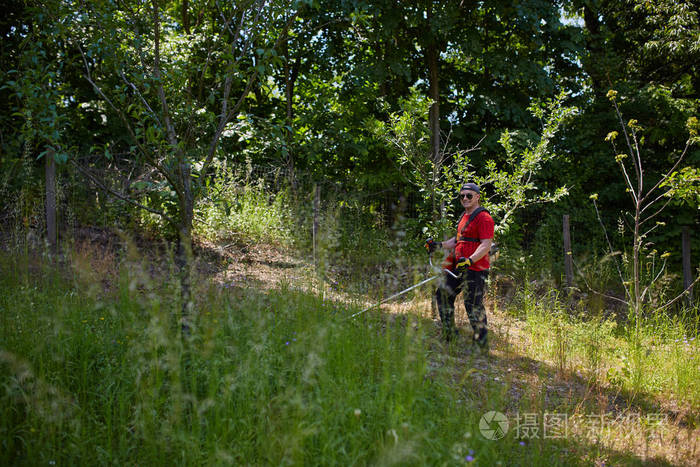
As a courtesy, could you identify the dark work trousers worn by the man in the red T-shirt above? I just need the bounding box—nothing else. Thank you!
[435,269,489,345]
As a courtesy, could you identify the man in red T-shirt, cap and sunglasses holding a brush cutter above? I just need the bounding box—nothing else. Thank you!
[426,183,494,349]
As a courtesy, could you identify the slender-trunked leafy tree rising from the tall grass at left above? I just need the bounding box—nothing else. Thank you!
[70,0,305,331]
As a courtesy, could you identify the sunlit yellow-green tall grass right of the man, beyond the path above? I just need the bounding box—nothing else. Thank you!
[508,283,700,407]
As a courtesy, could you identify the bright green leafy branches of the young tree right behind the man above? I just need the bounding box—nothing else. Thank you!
[370,90,576,245]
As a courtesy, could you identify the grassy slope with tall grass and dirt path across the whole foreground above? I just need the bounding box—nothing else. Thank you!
[0,239,700,465]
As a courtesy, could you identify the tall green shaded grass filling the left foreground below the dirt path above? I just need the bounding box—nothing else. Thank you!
[0,247,608,465]
